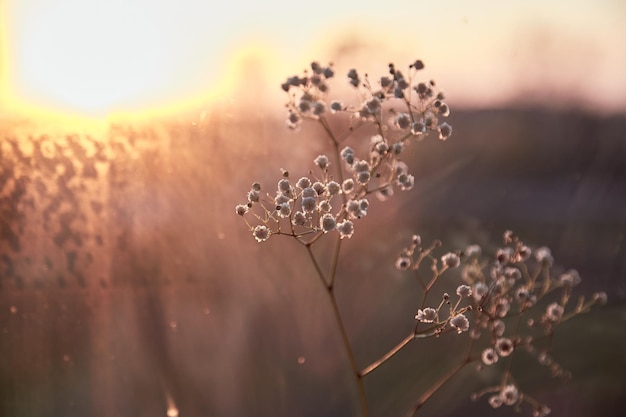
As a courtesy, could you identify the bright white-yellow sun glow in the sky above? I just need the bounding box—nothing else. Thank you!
[0,0,282,120]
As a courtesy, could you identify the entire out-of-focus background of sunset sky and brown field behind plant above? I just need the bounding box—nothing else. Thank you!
[0,0,626,417]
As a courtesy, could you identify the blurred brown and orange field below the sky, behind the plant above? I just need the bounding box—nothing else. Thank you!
[0,105,626,417]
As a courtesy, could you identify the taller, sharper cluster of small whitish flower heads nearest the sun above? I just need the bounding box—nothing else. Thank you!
[235,61,453,240]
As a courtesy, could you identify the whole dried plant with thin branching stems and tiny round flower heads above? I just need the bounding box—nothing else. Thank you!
[235,60,606,417]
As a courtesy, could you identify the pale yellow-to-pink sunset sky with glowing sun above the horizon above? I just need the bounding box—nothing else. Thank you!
[0,0,626,117]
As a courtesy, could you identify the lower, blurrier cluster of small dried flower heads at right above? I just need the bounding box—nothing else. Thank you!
[395,231,606,415]
